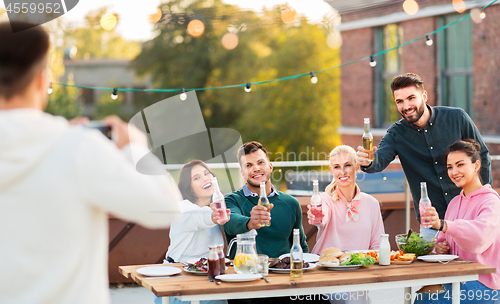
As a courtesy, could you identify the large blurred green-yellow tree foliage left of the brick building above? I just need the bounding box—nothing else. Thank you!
[134,0,341,160]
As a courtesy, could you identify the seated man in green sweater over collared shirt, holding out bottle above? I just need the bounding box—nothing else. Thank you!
[224,141,309,258]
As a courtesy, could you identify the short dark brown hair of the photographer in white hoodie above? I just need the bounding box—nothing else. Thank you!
[0,21,50,100]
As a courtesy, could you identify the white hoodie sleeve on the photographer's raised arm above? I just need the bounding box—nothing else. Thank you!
[76,132,182,228]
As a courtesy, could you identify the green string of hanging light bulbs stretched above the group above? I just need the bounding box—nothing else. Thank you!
[53,0,498,93]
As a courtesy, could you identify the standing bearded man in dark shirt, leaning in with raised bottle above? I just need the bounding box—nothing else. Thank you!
[357,73,492,222]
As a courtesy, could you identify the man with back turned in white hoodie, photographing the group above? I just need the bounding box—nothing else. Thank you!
[0,22,181,304]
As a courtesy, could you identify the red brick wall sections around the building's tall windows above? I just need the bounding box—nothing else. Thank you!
[341,4,500,187]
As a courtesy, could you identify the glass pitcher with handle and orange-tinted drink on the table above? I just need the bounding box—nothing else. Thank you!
[227,229,259,273]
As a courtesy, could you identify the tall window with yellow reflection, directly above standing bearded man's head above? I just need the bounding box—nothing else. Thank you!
[373,24,403,128]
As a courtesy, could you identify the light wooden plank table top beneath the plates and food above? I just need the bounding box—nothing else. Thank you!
[119,260,496,297]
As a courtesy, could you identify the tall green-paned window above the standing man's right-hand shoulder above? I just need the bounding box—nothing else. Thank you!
[438,14,474,117]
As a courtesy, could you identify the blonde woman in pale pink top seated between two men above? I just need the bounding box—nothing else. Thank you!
[307,145,384,254]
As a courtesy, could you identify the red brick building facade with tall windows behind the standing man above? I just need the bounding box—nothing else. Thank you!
[326,0,500,187]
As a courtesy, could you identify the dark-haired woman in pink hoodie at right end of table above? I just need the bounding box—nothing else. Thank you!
[415,139,500,304]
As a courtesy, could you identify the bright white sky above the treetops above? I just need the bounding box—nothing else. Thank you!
[0,0,333,40]
